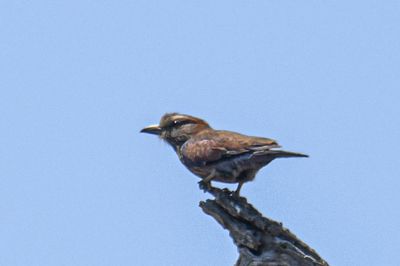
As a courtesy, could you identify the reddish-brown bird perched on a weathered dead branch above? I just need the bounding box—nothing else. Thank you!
[140,113,308,196]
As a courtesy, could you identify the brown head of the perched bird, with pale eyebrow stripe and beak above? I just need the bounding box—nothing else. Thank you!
[140,113,210,148]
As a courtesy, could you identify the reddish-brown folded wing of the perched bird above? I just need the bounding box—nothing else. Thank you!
[181,131,280,163]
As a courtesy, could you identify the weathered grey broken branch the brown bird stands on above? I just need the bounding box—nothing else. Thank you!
[200,187,328,266]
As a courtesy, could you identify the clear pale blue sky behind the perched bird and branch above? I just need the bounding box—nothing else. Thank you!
[0,0,400,266]
